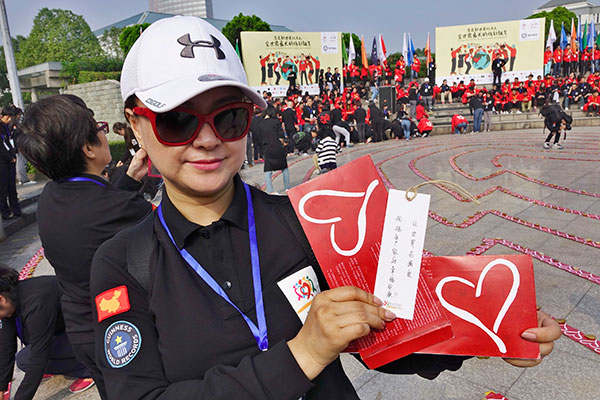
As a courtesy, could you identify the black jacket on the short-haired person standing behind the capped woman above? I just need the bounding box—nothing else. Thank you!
[37,174,152,344]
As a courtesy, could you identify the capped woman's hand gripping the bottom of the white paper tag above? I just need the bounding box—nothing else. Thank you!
[288,286,396,380]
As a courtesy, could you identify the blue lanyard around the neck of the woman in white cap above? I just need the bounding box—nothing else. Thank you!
[158,182,269,351]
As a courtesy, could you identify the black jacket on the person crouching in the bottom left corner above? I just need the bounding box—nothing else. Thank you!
[0,276,65,400]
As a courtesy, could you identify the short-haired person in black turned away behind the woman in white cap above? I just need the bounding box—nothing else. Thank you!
[17,95,152,399]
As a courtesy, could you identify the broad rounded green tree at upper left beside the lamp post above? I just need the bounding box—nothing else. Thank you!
[15,8,102,68]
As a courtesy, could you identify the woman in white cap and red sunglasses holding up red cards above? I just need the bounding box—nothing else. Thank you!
[91,17,554,400]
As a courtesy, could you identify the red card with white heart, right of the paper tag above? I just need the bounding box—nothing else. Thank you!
[421,255,540,359]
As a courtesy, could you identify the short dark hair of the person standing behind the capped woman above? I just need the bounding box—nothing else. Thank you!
[16,94,99,180]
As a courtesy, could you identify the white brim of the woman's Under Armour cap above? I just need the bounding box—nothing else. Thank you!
[135,76,267,113]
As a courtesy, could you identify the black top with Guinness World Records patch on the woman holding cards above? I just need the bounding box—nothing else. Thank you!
[91,176,464,400]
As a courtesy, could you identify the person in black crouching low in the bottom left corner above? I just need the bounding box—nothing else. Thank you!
[0,266,94,399]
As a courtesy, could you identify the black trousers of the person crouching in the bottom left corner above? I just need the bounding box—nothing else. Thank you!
[16,332,91,378]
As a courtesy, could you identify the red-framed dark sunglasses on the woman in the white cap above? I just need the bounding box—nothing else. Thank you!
[133,102,254,146]
